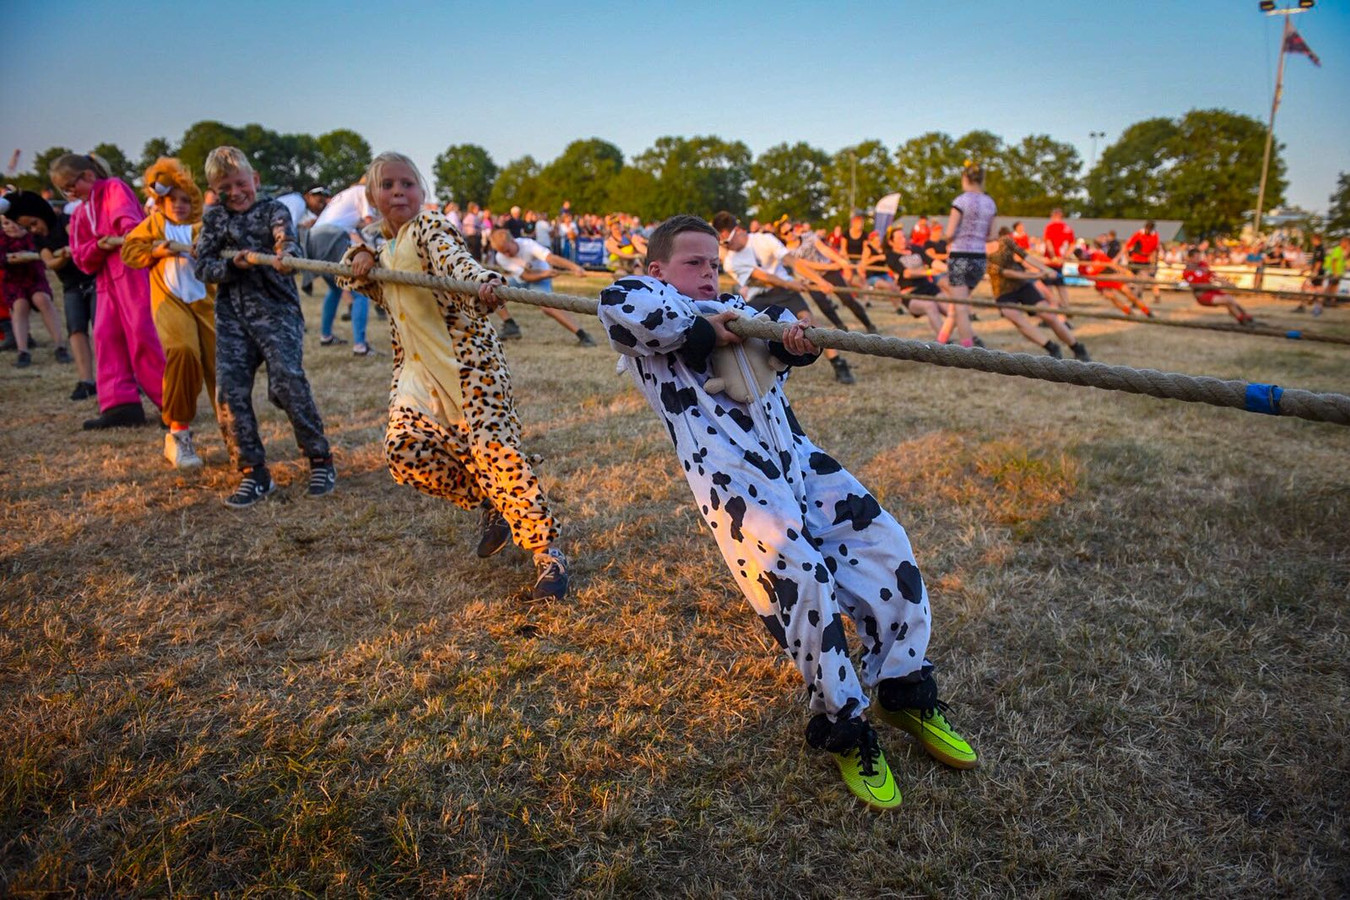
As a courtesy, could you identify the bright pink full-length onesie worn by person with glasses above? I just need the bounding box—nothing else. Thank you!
[69,178,165,410]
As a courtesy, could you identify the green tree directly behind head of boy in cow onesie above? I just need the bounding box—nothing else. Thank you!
[633,135,751,219]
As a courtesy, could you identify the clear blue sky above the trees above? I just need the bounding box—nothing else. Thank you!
[0,0,1350,210]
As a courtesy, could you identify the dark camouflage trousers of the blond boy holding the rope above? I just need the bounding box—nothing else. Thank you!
[216,290,329,470]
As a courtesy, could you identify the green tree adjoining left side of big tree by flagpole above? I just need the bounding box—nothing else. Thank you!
[1087,119,1177,219]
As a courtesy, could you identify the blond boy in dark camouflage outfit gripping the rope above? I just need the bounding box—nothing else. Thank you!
[196,147,338,509]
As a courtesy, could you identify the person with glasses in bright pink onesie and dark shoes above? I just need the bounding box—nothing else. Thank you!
[49,154,165,429]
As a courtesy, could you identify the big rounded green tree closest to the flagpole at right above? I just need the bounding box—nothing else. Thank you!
[1165,109,1287,236]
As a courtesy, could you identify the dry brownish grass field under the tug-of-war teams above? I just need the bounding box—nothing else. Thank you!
[0,282,1350,897]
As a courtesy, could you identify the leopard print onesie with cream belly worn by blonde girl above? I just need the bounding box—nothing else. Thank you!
[338,212,558,551]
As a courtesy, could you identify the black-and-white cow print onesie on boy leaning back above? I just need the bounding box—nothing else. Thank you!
[599,277,932,719]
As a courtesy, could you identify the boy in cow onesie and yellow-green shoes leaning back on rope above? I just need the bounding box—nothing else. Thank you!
[599,216,976,808]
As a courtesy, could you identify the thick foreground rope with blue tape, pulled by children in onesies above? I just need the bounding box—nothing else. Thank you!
[237,251,1350,425]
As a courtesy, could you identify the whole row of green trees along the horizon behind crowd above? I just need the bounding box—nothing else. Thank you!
[14,109,1337,236]
